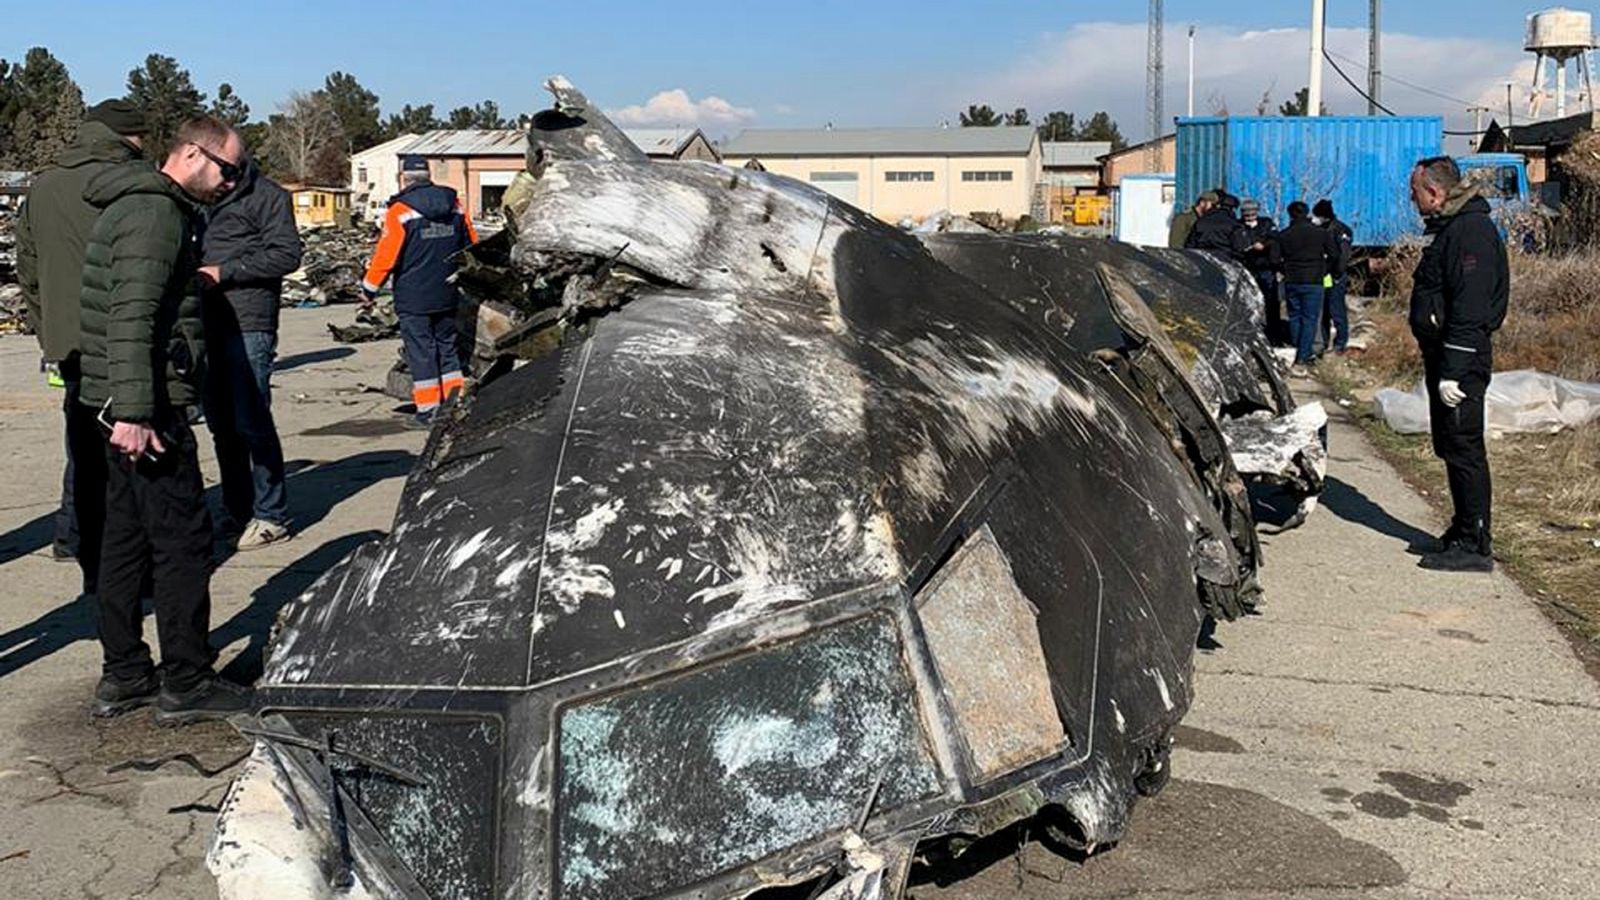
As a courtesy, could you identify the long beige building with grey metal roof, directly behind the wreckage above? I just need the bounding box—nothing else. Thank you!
[722,125,1040,221]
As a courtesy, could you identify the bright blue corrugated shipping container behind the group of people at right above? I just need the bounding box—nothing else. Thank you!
[1178,115,1445,247]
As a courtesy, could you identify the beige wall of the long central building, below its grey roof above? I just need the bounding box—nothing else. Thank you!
[723,150,1038,221]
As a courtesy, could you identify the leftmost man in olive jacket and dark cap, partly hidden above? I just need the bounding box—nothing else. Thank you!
[16,99,146,594]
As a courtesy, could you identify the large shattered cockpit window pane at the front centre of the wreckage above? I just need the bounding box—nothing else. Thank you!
[557,615,939,900]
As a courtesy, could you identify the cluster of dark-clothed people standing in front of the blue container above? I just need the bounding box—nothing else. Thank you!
[1168,189,1352,373]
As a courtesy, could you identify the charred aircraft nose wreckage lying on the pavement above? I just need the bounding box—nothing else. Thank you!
[208,78,1320,900]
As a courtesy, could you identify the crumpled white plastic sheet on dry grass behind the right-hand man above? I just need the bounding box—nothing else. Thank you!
[1373,368,1600,434]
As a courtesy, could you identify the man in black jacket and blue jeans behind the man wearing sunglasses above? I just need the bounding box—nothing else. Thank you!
[200,160,302,551]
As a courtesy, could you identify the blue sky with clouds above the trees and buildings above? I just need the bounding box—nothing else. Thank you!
[0,0,1531,138]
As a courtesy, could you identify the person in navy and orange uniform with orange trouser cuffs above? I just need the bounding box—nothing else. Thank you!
[362,155,478,428]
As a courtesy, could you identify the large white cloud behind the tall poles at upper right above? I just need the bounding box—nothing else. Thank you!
[942,22,1531,141]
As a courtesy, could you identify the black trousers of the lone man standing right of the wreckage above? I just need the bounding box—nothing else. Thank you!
[1422,348,1493,552]
